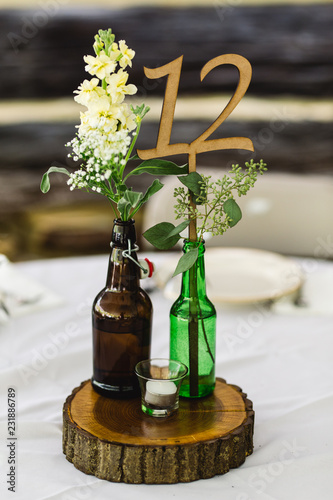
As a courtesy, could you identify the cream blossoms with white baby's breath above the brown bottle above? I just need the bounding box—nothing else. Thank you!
[67,30,145,196]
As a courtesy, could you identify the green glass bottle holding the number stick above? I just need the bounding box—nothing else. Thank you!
[170,240,216,398]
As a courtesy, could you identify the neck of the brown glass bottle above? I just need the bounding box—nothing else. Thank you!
[106,219,140,292]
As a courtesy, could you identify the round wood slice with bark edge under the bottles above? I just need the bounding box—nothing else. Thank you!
[63,378,254,484]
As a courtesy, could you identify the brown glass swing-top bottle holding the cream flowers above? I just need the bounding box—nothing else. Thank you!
[92,219,152,398]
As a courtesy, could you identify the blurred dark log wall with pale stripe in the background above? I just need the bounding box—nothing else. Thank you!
[0,1,333,259]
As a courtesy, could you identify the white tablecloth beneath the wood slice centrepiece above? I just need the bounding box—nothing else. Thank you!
[0,256,333,500]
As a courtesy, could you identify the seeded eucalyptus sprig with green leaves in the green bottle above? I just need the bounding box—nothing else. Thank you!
[143,160,267,276]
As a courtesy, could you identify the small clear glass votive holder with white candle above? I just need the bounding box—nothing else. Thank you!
[135,358,188,417]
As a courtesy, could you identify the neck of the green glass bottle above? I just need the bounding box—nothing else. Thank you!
[181,240,206,298]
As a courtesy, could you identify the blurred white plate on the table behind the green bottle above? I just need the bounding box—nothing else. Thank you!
[156,248,304,304]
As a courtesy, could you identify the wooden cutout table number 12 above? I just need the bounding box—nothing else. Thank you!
[137,54,254,172]
